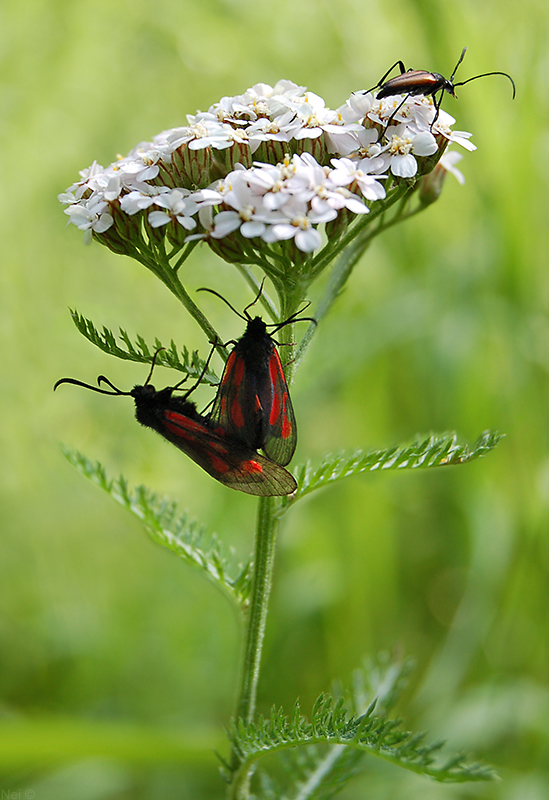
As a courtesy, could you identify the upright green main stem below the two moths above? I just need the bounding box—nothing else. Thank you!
[228,497,279,800]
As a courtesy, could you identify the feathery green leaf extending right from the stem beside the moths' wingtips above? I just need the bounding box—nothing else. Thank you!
[282,431,503,510]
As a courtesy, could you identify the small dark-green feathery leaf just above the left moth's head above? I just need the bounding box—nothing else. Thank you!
[71,309,219,386]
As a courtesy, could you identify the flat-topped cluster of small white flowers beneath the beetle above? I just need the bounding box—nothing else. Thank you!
[59,81,475,253]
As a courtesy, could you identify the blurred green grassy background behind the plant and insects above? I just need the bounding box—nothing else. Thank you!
[0,0,549,800]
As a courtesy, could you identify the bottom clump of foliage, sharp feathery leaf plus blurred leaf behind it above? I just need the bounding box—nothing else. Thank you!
[229,658,495,800]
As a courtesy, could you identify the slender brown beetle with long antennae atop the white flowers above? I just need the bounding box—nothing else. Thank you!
[368,47,516,130]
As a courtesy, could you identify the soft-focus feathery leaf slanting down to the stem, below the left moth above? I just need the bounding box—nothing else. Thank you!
[62,446,250,603]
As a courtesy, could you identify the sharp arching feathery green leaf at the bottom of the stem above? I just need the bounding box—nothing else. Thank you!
[229,694,495,800]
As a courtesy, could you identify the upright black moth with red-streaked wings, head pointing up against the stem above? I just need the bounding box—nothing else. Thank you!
[199,286,315,466]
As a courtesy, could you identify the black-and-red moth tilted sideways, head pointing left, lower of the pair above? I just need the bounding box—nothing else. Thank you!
[53,355,297,497]
